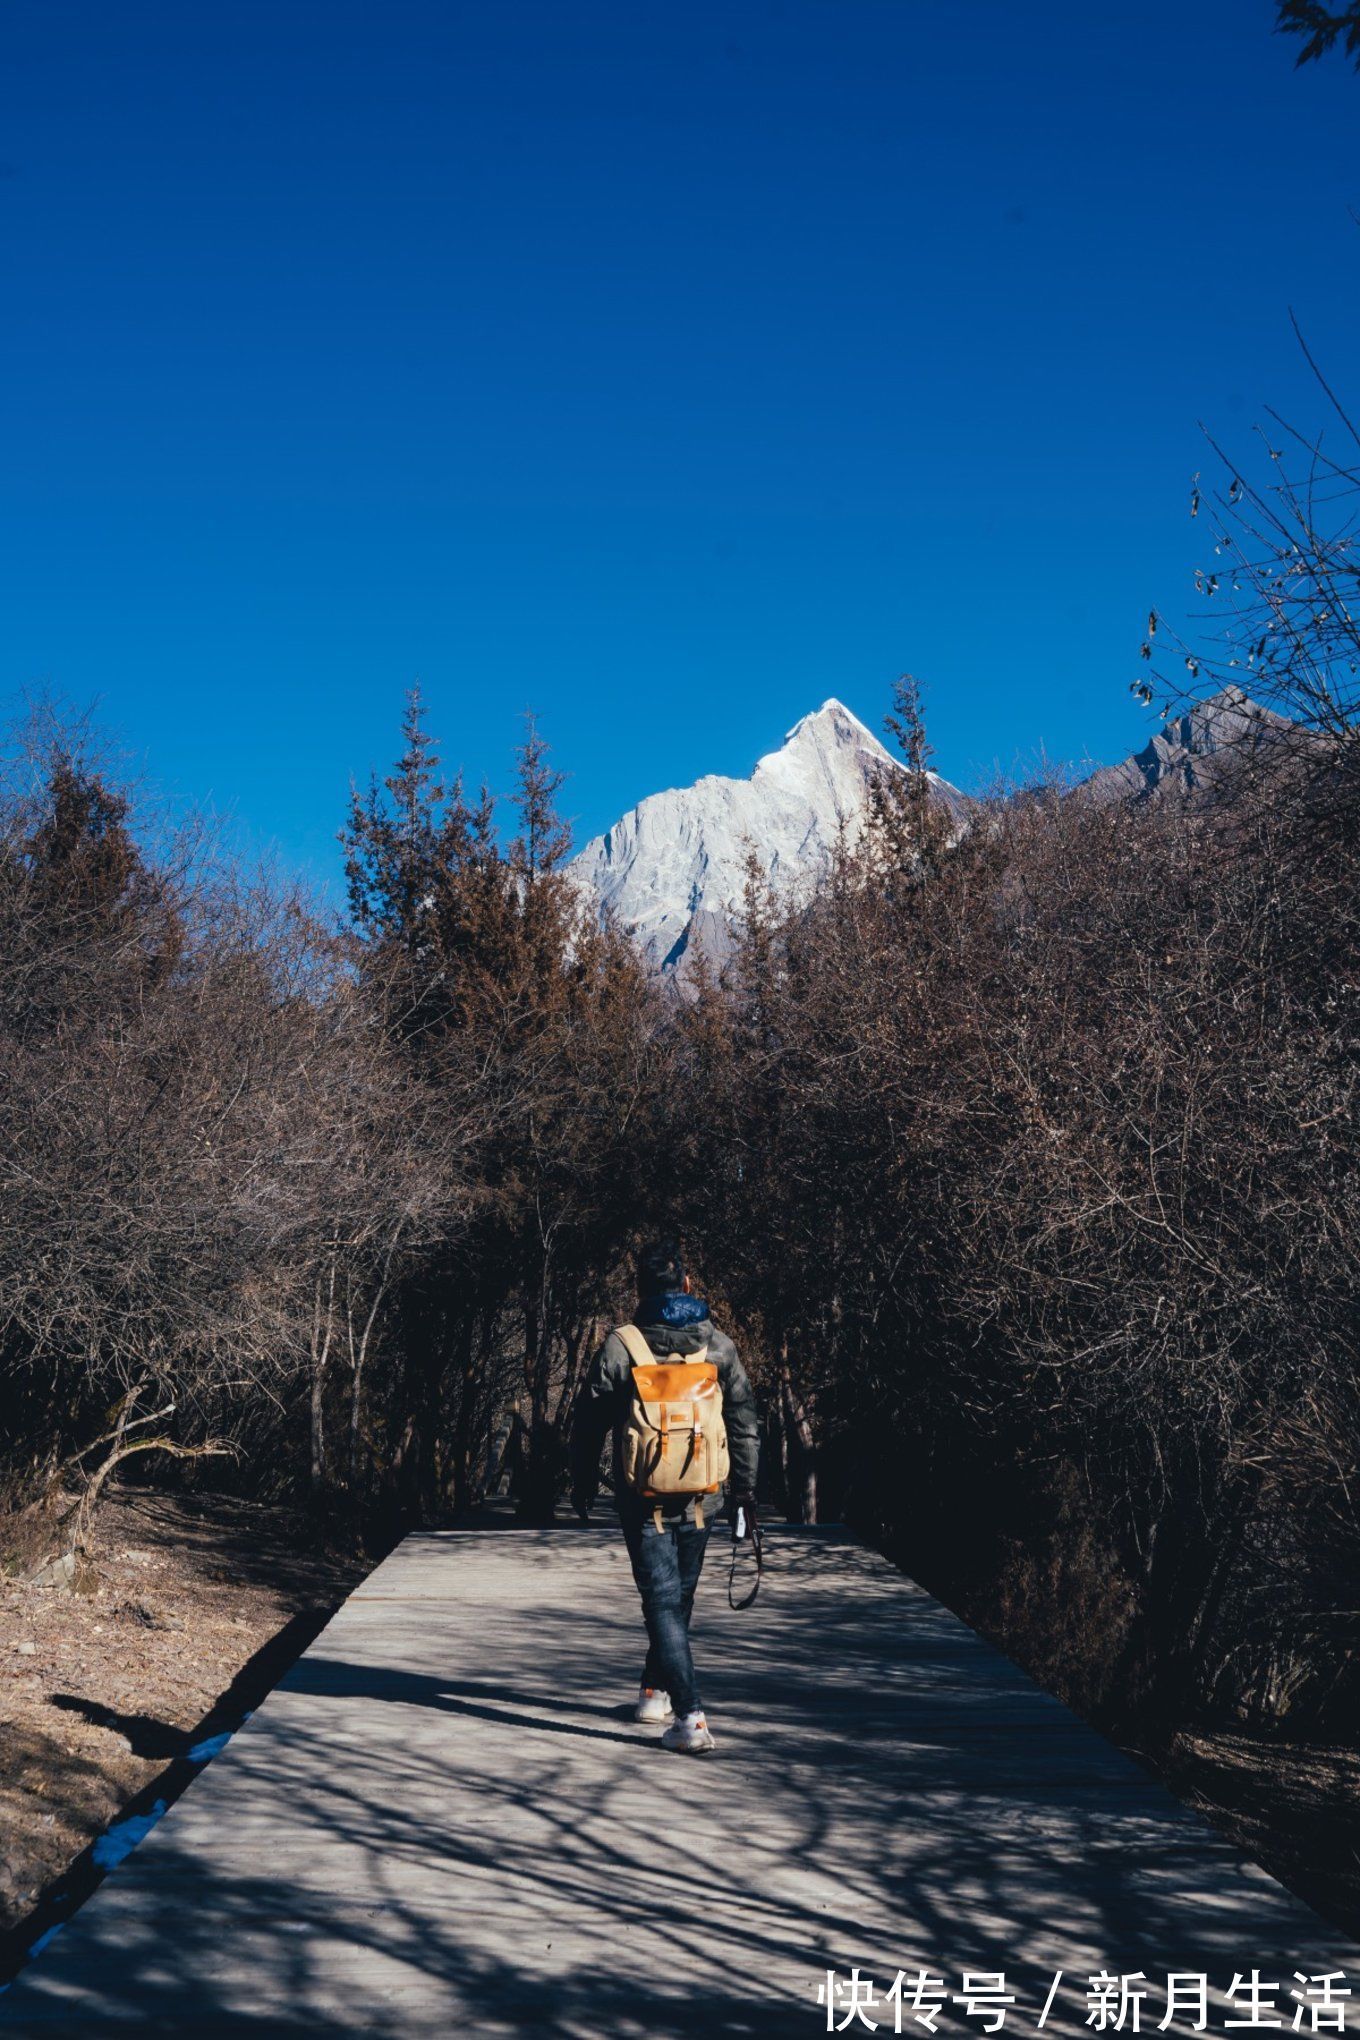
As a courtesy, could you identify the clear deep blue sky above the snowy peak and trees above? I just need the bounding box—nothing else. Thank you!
[0,0,1360,893]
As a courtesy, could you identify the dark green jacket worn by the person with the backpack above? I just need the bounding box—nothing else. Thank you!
[571,1293,761,1516]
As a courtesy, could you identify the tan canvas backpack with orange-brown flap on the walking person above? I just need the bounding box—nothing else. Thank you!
[618,1324,728,1528]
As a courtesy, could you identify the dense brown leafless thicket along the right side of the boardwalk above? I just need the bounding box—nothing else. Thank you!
[685,718,1360,1720]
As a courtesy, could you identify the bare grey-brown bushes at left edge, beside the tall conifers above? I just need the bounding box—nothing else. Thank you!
[0,714,426,1557]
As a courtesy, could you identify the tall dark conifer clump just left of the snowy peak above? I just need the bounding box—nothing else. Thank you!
[345,698,663,1520]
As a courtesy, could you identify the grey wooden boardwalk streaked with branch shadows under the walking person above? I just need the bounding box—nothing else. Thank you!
[0,1528,1360,2040]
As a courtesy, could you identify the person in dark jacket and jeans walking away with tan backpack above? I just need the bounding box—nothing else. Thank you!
[571,1240,761,1754]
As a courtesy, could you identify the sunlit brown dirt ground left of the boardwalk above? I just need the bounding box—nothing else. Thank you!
[0,1491,371,1969]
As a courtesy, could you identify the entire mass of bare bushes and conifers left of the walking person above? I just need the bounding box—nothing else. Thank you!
[0,704,661,1567]
